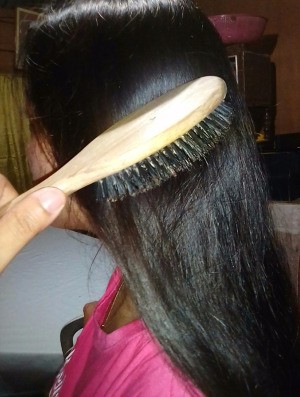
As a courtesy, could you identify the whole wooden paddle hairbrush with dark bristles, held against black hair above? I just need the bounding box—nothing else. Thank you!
[0,76,232,214]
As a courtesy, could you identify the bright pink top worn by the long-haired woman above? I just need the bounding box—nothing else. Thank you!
[49,270,204,397]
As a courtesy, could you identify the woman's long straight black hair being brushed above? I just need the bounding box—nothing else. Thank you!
[25,0,300,397]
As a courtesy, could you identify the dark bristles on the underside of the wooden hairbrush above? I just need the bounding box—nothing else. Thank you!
[97,102,233,201]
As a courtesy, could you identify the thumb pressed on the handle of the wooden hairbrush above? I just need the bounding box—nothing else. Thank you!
[0,188,66,272]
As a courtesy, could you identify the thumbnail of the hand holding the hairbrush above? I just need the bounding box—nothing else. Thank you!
[32,187,66,214]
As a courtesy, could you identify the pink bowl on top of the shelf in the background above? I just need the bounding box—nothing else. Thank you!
[208,14,267,44]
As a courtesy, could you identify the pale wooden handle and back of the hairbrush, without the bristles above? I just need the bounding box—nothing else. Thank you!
[0,76,226,215]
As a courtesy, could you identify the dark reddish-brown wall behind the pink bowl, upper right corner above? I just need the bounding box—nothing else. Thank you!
[197,0,300,134]
